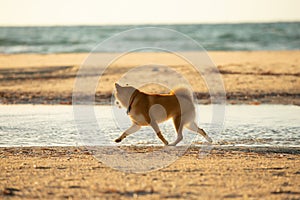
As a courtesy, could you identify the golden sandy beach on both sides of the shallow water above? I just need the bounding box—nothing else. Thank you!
[0,51,300,199]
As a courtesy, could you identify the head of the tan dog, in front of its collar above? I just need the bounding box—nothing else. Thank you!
[115,83,137,108]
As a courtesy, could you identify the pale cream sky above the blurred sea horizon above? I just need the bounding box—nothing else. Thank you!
[0,0,300,26]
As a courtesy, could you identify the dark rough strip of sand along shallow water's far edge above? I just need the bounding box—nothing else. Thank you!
[0,91,300,106]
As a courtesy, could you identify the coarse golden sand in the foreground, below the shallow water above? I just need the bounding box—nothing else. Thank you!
[0,147,300,199]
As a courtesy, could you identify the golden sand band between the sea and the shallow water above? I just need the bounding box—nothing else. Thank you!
[0,51,300,105]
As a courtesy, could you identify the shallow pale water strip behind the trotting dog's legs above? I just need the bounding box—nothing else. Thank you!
[0,105,300,147]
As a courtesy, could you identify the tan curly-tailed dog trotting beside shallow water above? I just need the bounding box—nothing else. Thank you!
[115,83,212,146]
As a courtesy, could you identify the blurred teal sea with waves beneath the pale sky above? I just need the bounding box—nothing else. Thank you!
[0,22,300,54]
